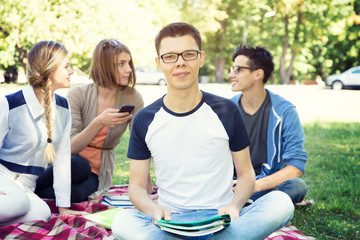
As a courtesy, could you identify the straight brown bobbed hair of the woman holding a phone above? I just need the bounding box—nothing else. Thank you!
[89,39,136,89]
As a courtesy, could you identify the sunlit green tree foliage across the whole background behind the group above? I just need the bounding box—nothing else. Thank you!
[0,0,360,82]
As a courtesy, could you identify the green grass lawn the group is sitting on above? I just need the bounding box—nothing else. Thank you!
[113,123,360,239]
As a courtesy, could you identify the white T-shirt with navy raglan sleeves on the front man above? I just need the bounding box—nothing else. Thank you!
[128,92,250,212]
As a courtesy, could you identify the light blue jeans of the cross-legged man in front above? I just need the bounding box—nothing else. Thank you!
[112,191,294,240]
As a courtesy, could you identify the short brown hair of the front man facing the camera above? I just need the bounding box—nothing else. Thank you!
[155,22,201,55]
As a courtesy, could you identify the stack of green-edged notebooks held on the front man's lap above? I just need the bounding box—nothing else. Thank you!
[155,214,231,236]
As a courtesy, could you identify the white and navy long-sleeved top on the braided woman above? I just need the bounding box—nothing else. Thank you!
[0,85,71,207]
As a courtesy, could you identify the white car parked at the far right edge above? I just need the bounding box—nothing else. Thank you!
[326,66,360,90]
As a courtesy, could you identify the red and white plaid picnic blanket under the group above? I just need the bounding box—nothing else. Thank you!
[0,186,315,240]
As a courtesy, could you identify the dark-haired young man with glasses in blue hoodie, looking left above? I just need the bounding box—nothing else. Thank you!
[229,45,307,204]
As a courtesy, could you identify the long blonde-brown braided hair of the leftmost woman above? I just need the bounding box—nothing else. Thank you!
[26,41,68,163]
